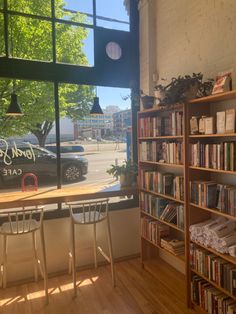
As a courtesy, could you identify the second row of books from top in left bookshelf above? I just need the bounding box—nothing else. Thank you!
[139,141,184,165]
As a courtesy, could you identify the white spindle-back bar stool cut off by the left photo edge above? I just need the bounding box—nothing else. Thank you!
[0,206,48,303]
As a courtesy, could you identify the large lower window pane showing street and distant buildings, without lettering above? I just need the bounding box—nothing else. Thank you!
[59,84,131,201]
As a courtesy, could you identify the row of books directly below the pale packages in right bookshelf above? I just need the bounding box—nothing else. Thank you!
[190,142,236,171]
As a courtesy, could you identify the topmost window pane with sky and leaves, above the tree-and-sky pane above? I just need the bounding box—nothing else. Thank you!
[55,0,93,24]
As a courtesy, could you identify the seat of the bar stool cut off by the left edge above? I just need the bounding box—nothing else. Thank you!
[0,219,40,235]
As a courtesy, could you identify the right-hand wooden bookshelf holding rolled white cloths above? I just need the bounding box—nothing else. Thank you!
[185,91,236,313]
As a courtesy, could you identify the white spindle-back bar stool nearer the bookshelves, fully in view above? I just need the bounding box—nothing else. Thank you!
[67,199,115,296]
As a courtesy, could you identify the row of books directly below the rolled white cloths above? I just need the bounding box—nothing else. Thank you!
[190,243,236,295]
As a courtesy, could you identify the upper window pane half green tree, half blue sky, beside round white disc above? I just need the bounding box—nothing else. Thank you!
[56,23,94,66]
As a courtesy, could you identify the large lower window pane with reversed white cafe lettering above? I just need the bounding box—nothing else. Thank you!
[0,79,57,192]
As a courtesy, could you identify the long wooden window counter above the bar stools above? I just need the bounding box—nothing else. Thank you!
[0,184,137,209]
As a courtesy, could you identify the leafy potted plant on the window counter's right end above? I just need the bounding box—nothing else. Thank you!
[107,159,137,187]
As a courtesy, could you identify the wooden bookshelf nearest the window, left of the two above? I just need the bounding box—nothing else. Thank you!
[138,103,186,306]
